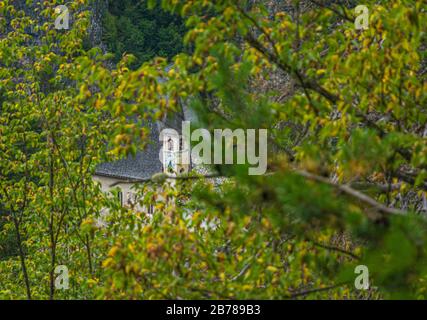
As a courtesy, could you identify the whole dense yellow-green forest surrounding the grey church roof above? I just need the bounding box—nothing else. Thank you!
[0,0,427,300]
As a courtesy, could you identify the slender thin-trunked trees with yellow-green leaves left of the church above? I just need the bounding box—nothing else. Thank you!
[0,1,135,299]
